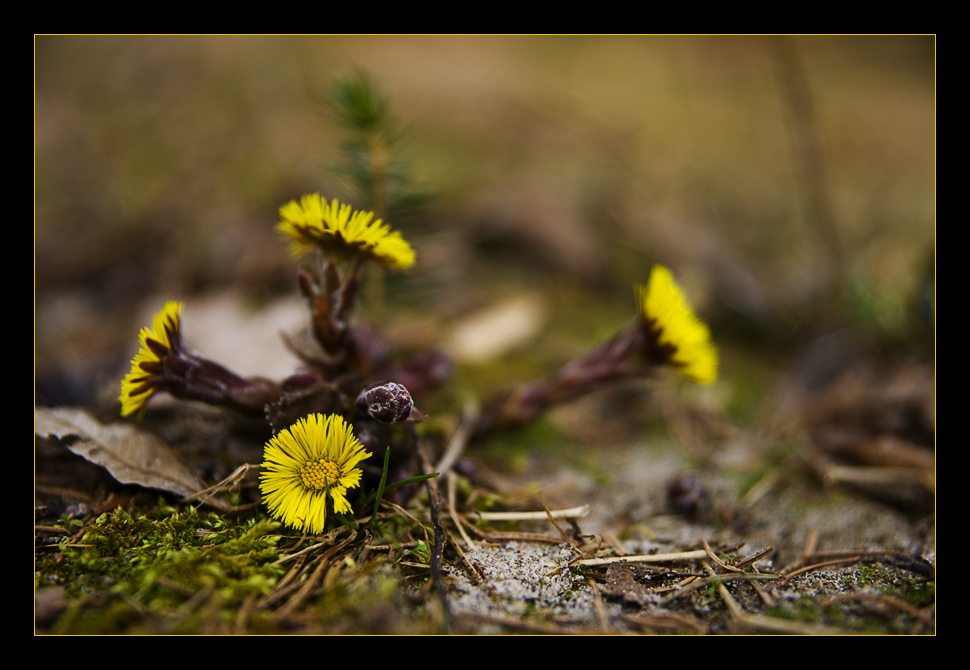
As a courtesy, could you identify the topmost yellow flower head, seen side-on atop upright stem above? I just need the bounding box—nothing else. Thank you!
[276,193,415,270]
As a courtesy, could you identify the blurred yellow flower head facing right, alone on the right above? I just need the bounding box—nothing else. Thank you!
[638,265,717,384]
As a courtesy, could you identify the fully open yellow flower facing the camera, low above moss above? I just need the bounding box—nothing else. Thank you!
[259,414,372,534]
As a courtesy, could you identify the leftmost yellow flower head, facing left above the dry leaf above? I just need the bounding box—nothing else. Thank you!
[120,301,182,416]
